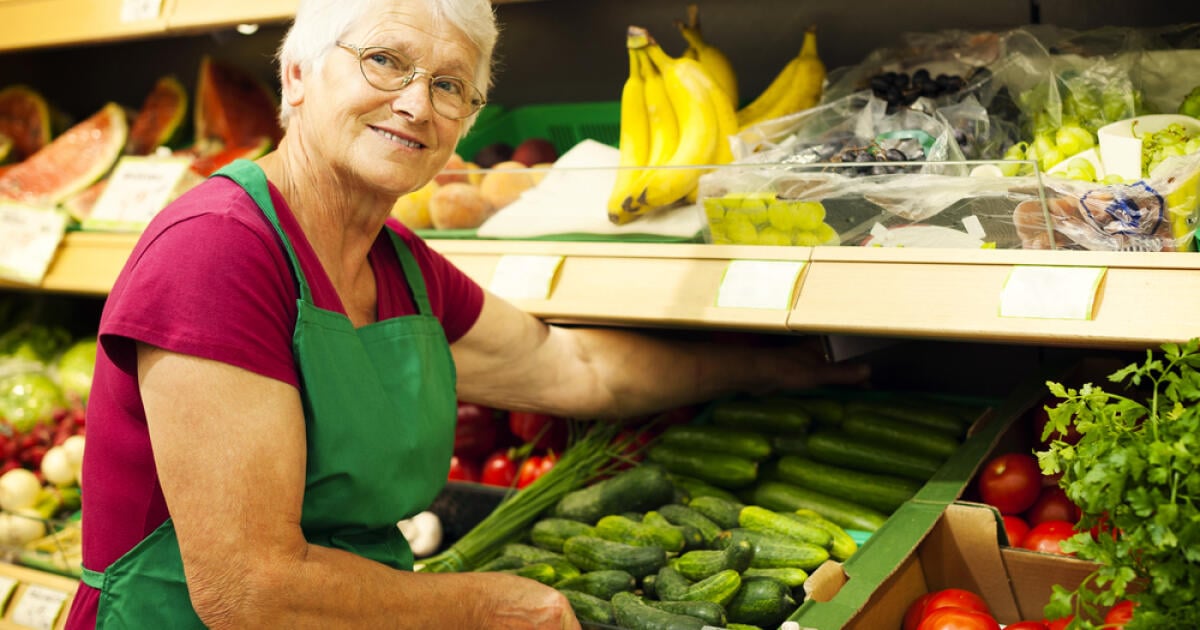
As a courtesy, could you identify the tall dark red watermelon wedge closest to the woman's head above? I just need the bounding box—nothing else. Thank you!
[194,56,283,146]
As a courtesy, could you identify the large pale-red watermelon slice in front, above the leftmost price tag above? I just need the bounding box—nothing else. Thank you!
[0,103,130,206]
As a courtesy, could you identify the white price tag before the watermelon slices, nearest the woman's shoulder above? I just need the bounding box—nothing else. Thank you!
[83,156,191,232]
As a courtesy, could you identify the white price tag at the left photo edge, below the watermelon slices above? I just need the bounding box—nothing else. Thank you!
[0,203,67,284]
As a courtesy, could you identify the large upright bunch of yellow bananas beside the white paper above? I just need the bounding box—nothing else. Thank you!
[608,26,737,224]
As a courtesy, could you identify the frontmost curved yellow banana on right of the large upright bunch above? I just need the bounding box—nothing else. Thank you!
[617,38,724,221]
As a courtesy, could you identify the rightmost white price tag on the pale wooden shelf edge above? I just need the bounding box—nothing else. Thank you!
[1000,265,1108,319]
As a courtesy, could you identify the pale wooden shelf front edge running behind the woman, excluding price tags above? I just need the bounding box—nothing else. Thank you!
[9,232,1200,348]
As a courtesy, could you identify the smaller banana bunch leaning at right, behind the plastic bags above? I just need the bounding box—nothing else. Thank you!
[737,28,826,131]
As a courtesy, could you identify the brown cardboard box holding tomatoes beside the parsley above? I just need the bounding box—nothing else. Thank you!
[798,503,1096,630]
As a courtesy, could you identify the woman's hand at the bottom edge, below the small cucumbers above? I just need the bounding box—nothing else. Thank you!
[474,574,580,630]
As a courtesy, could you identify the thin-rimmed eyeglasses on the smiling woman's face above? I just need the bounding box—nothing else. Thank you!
[336,42,487,120]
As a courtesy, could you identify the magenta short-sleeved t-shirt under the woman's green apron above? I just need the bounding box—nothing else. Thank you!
[67,178,484,628]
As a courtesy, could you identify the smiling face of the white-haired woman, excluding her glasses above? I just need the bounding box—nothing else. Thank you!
[296,1,480,197]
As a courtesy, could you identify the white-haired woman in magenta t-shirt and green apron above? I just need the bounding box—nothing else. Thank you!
[67,0,863,630]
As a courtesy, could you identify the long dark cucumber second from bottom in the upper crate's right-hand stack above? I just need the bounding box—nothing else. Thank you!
[775,455,920,514]
